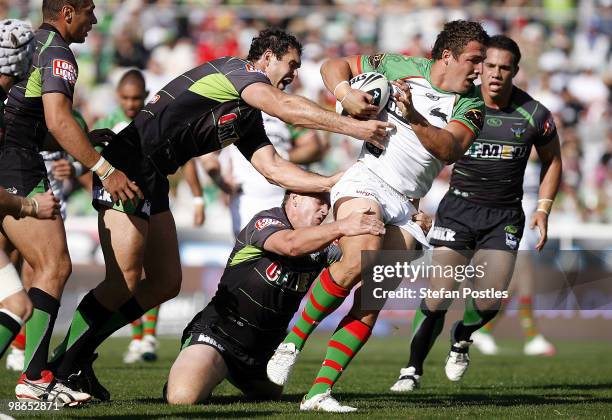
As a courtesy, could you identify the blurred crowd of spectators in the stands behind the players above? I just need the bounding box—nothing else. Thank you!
[0,0,612,223]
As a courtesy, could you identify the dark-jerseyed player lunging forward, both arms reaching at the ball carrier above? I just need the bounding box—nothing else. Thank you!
[50,30,393,399]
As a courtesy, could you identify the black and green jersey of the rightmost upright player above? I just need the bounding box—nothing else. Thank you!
[450,87,557,207]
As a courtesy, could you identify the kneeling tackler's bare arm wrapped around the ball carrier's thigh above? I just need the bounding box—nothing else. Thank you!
[264,208,385,257]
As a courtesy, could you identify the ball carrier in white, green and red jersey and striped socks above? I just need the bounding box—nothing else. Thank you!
[267,21,488,412]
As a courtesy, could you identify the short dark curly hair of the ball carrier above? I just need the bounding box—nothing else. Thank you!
[431,20,489,60]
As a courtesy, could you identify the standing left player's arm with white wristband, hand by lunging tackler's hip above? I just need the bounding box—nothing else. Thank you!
[42,92,144,202]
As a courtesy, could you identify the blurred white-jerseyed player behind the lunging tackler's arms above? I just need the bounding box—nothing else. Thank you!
[219,113,323,236]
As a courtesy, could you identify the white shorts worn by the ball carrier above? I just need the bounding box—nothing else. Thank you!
[331,161,431,248]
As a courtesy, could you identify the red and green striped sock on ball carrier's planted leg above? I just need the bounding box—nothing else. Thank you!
[306,316,372,399]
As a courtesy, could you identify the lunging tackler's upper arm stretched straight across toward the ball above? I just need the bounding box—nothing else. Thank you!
[242,83,394,149]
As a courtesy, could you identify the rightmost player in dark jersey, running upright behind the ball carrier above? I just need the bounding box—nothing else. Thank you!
[391,35,561,392]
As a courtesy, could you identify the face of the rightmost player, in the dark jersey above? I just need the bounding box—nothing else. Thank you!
[480,48,517,98]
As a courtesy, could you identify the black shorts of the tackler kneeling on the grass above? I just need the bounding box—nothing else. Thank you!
[181,313,274,393]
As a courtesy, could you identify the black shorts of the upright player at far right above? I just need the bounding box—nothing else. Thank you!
[429,191,525,250]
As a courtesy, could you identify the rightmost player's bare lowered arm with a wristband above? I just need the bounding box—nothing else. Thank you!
[530,136,563,251]
